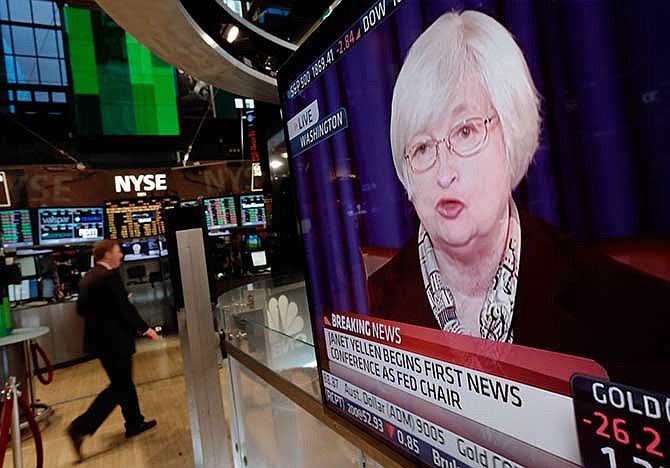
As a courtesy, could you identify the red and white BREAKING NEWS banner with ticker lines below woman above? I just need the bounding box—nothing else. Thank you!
[323,313,607,468]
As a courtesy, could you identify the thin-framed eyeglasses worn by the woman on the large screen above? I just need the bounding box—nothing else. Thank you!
[405,115,497,173]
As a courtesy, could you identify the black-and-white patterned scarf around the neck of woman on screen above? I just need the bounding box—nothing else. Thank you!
[418,199,521,343]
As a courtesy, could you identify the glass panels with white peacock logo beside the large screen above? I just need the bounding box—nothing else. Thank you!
[215,277,381,468]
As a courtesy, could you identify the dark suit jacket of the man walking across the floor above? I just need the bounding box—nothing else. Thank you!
[77,264,149,357]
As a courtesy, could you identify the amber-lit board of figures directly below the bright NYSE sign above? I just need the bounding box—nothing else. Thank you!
[105,198,174,239]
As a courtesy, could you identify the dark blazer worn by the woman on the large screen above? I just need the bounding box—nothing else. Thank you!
[368,212,670,394]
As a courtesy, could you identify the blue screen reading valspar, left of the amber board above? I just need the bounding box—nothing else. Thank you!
[37,207,104,245]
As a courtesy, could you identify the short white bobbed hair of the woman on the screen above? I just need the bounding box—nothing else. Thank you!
[390,11,540,196]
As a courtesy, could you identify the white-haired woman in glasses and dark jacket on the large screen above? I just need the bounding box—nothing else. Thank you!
[368,11,670,390]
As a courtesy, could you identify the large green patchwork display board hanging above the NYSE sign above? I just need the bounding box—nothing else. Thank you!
[63,6,179,136]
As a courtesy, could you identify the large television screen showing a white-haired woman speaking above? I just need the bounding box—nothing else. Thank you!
[278,0,670,468]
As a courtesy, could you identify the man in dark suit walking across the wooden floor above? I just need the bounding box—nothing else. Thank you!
[68,240,158,458]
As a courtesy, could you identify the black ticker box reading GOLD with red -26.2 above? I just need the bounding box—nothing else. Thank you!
[572,376,670,468]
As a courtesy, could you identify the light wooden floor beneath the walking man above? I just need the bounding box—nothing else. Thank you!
[5,337,200,468]
